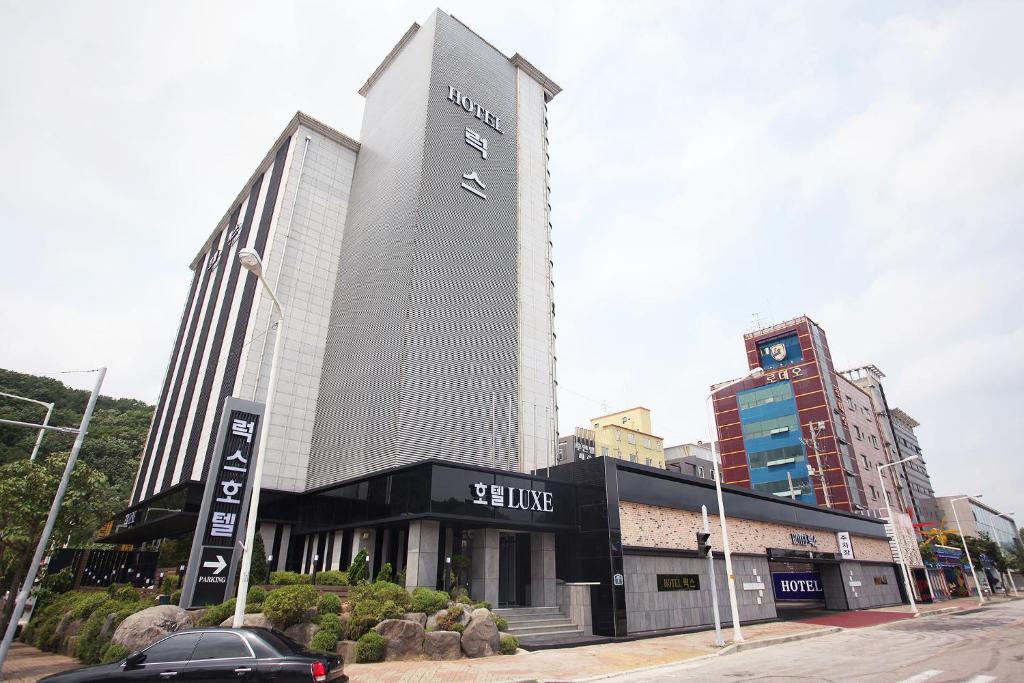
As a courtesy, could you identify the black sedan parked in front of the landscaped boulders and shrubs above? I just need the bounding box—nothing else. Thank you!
[42,627,348,683]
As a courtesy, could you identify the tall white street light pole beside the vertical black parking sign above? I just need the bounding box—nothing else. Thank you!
[231,249,285,629]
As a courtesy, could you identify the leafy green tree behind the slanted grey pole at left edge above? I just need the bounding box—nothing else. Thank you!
[0,454,113,628]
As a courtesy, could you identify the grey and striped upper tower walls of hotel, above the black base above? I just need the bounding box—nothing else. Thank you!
[131,10,559,509]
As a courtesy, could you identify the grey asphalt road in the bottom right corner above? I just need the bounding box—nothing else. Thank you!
[605,600,1024,683]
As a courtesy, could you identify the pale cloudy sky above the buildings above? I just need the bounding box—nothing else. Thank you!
[0,0,1024,516]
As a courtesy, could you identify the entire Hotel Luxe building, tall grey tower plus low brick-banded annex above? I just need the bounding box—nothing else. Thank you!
[103,10,913,636]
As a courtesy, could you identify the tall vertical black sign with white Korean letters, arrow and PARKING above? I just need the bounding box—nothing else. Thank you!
[180,396,263,607]
